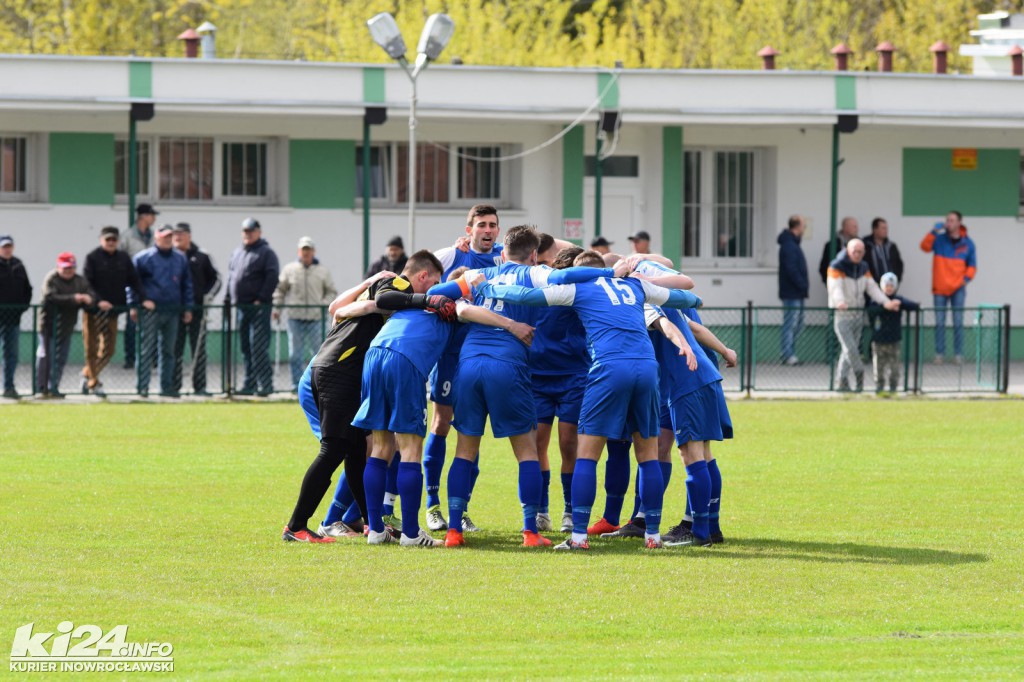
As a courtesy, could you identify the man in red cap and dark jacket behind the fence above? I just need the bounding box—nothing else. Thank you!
[36,251,96,398]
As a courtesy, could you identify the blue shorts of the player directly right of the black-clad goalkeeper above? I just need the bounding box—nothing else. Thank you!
[352,347,427,437]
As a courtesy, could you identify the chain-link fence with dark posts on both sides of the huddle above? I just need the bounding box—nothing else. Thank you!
[0,305,1010,398]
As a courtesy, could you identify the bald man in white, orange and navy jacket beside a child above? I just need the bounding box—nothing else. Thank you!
[827,238,899,392]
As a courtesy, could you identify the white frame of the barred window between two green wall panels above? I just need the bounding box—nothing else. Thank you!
[115,134,282,206]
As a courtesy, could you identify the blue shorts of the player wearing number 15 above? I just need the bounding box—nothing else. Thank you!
[578,359,658,440]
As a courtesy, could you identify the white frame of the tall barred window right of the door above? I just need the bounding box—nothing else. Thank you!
[679,146,765,267]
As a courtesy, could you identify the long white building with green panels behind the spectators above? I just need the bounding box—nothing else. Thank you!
[0,55,1024,329]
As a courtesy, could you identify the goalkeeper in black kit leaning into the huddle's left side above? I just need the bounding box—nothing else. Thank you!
[282,250,457,543]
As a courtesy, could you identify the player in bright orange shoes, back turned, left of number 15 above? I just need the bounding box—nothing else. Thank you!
[431,225,628,547]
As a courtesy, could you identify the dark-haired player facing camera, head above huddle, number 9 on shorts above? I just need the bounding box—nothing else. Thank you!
[423,204,503,531]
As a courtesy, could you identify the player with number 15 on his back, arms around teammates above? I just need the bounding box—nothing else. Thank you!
[481,252,700,551]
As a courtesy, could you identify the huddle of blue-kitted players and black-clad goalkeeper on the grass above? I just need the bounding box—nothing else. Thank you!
[283,205,736,551]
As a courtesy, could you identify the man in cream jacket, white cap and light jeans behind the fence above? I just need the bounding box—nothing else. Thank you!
[273,237,335,393]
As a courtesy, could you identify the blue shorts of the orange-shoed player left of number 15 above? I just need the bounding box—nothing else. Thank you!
[452,357,537,438]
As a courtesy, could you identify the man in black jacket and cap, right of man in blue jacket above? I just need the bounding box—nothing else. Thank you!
[171,222,220,395]
